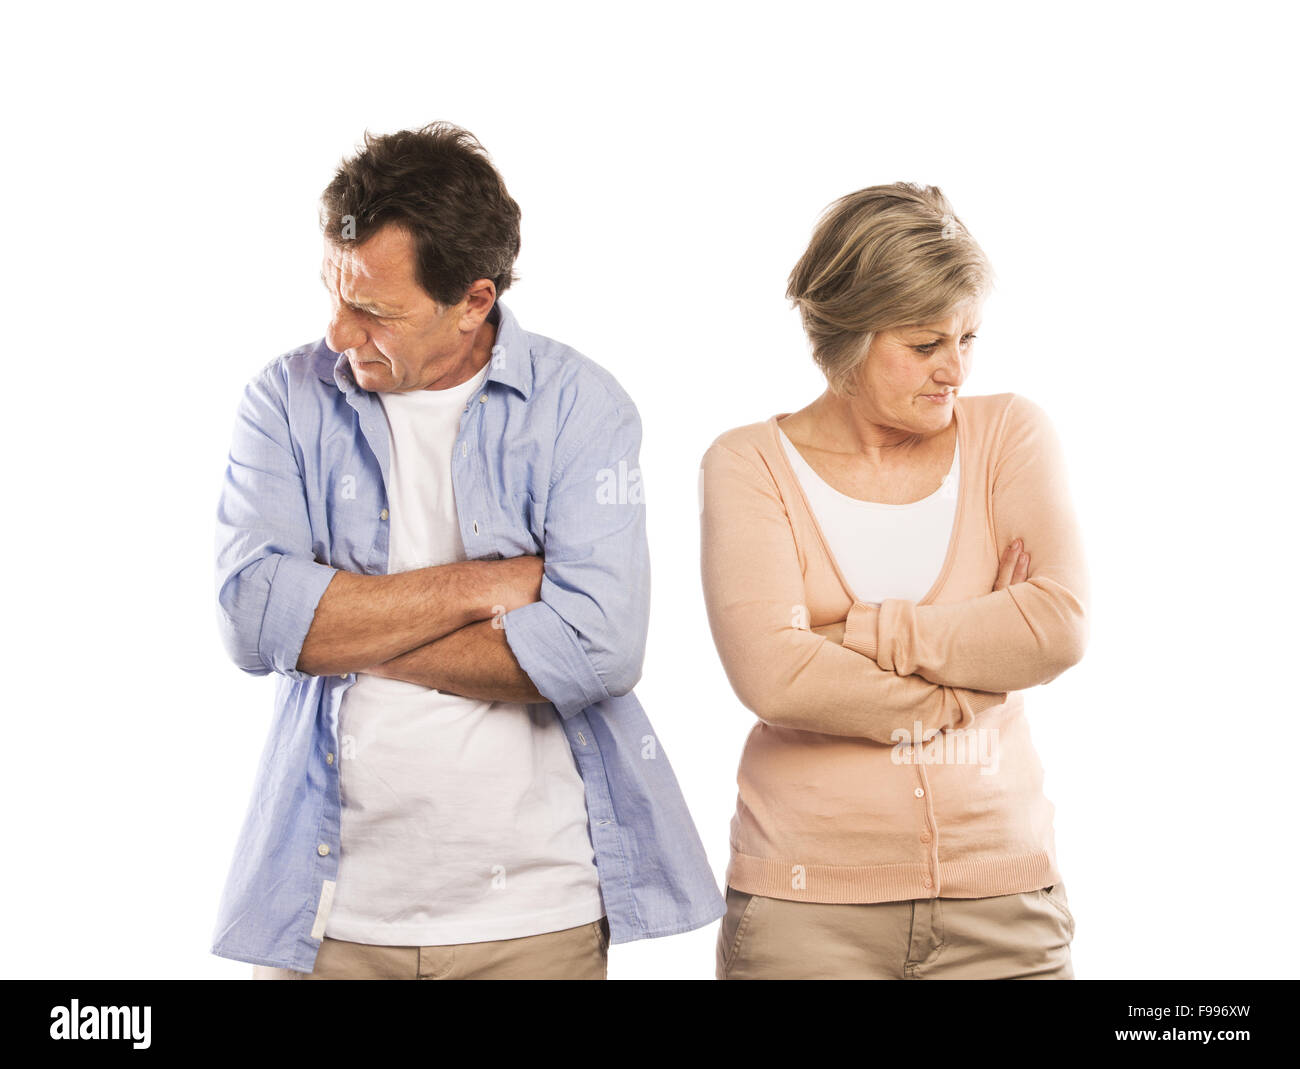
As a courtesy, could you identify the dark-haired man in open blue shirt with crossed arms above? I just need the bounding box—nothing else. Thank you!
[212,124,725,979]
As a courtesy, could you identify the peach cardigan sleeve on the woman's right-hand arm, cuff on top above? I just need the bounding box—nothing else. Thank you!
[844,395,1089,691]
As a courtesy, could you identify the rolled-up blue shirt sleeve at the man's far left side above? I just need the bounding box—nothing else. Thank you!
[216,364,335,679]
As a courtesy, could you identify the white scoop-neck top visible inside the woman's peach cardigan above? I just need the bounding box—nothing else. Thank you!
[777,428,961,605]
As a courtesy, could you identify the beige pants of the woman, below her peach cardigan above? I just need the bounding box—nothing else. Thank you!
[716,883,1074,979]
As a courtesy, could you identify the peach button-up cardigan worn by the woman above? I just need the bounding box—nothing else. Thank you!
[701,393,1088,903]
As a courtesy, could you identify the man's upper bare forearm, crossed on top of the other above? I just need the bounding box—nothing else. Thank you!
[298,557,541,675]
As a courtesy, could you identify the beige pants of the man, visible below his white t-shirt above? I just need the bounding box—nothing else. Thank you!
[252,917,610,979]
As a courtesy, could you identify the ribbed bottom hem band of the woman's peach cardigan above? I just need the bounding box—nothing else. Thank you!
[727,851,1062,904]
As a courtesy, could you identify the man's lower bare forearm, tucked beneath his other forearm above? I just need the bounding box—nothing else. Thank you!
[364,620,546,702]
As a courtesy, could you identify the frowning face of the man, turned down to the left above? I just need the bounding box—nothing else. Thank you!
[321,224,480,393]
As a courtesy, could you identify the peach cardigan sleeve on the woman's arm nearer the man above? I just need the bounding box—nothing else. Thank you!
[699,442,1008,744]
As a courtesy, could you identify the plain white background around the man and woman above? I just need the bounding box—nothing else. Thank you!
[0,3,1300,978]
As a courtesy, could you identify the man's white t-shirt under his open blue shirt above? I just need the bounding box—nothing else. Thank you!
[325,367,605,947]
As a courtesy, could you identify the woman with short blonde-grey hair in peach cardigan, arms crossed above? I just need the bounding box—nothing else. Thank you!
[702,183,1088,979]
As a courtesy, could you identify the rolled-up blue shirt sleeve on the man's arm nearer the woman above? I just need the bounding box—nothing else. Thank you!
[503,401,650,718]
